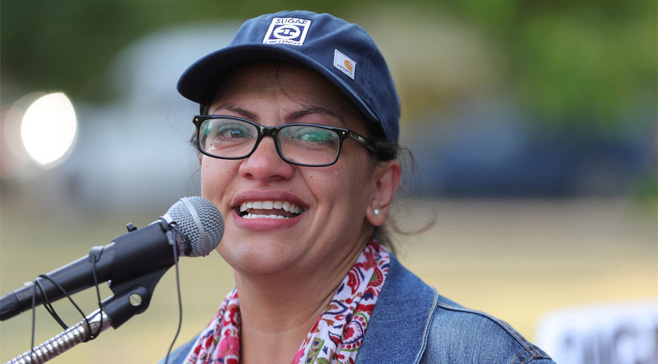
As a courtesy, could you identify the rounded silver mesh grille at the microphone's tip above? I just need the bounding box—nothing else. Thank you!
[167,196,224,257]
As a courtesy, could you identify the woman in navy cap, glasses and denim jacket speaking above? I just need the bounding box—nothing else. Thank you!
[160,11,552,364]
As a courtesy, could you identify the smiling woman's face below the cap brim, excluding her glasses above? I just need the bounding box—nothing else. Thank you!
[201,63,397,274]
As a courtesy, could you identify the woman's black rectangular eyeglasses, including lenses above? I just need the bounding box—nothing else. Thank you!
[193,115,375,167]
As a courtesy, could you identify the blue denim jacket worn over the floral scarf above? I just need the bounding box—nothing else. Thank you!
[160,255,554,364]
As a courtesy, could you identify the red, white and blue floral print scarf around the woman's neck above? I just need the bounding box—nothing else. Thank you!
[185,240,390,364]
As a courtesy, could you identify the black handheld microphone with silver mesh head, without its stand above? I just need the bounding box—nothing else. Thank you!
[0,196,224,321]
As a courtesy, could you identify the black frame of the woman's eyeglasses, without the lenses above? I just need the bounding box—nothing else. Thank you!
[192,115,376,167]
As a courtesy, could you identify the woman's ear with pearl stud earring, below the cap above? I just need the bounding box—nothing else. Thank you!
[366,160,402,226]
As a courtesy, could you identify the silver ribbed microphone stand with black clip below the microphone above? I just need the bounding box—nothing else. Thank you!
[5,267,169,364]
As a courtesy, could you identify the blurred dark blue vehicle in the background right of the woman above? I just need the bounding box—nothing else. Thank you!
[408,98,656,197]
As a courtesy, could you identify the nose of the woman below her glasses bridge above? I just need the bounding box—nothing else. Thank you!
[239,136,295,182]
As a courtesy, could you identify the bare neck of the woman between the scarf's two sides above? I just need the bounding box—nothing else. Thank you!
[235,232,368,364]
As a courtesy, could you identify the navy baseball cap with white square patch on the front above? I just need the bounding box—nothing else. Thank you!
[178,11,400,142]
